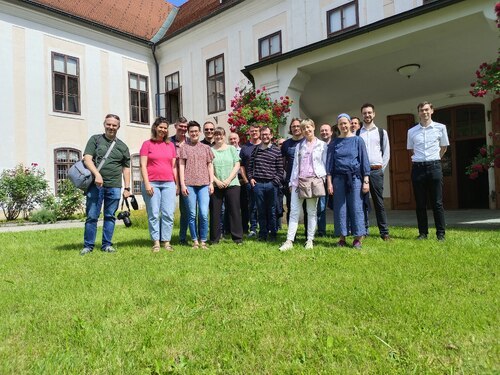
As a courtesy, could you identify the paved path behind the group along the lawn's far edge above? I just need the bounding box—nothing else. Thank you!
[0,210,500,233]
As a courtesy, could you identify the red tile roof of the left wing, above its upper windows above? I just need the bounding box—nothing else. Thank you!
[24,0,176,40]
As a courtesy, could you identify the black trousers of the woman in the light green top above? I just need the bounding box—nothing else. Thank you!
[210,186,243,242]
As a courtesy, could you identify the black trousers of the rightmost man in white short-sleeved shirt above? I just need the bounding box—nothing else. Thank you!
[411,160,445,236]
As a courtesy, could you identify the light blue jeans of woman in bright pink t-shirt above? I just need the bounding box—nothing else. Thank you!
[142,181,175,241]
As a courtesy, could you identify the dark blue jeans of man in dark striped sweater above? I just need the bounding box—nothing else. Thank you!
[253,182,278,239]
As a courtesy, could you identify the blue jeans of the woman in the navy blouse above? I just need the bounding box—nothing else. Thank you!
[332,175,366,237]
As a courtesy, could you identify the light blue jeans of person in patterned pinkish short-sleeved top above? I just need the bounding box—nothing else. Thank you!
[187,185,210,242]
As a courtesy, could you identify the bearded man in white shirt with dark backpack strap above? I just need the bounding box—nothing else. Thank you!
[356,103,391,241]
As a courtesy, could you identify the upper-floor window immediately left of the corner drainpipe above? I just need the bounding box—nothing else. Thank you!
[128,73,149,125]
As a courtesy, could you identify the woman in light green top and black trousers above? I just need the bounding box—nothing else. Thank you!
[210,127,243,245]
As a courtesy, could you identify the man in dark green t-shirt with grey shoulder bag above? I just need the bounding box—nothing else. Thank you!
[80,114,130,255]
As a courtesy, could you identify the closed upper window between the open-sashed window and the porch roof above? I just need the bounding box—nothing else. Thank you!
[207,54,226,114]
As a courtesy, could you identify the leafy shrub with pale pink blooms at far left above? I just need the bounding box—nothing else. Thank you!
[0,163,49,220]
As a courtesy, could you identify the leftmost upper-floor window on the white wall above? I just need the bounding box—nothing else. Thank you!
[52,52,80,115]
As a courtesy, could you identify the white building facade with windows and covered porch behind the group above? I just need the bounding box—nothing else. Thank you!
[0,0,500,209]
